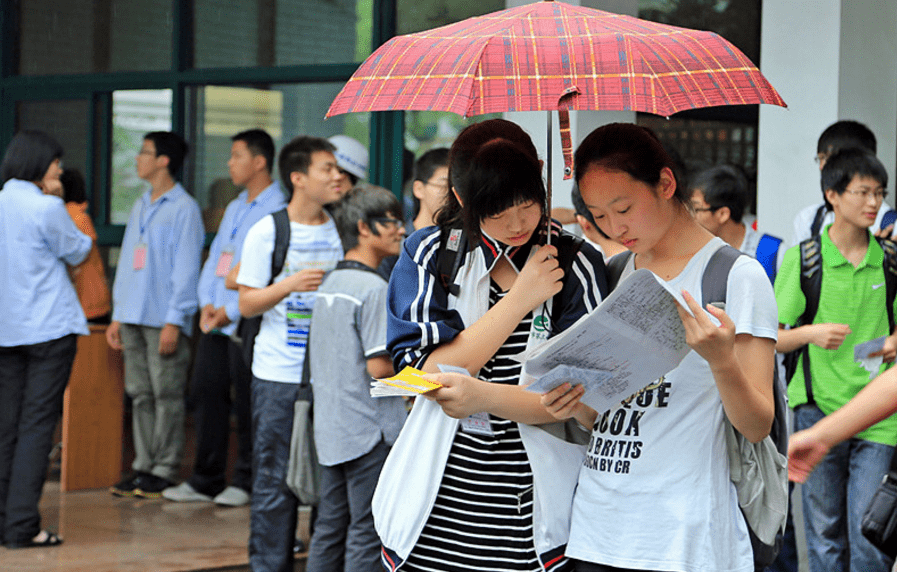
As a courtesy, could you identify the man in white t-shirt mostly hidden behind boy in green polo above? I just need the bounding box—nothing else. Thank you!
[789,120,897,246]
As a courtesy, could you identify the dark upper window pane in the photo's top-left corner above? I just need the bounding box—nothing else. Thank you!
[18,0,173,75]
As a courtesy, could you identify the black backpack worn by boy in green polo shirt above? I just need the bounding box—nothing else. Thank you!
[784,235,897,404]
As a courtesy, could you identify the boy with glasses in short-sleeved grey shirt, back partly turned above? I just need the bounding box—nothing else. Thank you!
[306,187,405,572]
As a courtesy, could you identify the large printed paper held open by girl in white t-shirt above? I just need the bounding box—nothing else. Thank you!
[523,269,700,412]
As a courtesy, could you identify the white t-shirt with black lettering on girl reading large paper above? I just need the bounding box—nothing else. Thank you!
[566,238,778,572]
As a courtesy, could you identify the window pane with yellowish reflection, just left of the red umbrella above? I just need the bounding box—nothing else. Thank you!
[190,83,370,232]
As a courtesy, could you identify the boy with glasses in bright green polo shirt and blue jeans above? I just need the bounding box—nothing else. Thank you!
[775,149,897,572]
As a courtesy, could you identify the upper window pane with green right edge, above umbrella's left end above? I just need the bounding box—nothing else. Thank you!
[194,0,373,68]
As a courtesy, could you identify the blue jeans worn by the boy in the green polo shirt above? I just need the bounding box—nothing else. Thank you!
[794,405,894,572]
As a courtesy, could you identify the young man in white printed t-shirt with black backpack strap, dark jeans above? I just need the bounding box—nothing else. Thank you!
[237,136,343,571]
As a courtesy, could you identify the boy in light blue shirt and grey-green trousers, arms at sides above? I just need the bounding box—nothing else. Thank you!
[106,131,205,498]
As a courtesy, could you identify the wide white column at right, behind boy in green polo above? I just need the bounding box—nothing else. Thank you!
[757,0,897,241]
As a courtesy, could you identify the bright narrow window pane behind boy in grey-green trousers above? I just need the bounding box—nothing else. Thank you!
[109,89,173,224]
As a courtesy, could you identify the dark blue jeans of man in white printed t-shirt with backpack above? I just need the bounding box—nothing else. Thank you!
[249,376,311,572]
